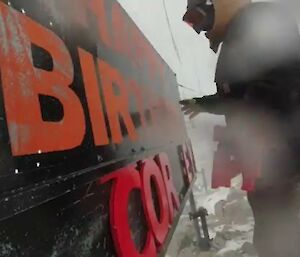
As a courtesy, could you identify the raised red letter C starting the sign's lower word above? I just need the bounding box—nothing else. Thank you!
[100,166,157,257]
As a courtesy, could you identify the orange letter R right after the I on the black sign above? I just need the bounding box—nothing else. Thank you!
[99,60,137,143]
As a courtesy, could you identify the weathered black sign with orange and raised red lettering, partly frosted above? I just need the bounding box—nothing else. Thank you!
[0,0,195,257]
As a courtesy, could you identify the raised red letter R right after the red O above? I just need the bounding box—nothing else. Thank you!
[155,154,180,224]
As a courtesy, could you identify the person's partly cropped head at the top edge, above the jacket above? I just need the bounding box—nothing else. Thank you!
[183,0,251,51]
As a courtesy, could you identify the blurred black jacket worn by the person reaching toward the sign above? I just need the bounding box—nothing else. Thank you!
[196,3,300,190]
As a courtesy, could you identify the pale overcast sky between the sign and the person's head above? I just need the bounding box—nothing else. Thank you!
[118,0,216,98]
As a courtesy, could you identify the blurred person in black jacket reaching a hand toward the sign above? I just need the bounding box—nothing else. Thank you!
[181,0,300,257]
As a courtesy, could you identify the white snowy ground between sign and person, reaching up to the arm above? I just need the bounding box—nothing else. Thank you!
[167,118,256,257]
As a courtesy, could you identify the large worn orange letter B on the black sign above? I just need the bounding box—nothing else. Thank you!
[0,3,85,155]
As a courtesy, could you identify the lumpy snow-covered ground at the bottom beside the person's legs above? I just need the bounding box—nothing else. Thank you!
[167,176,256,257]
